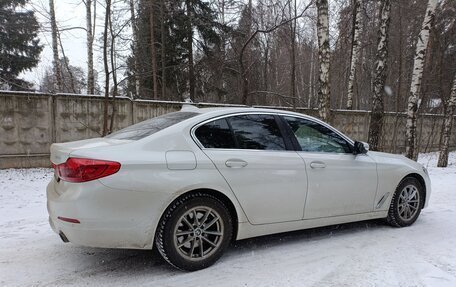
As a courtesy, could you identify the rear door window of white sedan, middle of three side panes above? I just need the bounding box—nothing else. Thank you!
[228,115,286,150]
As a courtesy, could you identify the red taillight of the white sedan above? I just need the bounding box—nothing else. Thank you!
[55,157,120,182]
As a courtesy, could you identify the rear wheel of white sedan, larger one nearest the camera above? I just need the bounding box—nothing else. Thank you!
[155,193,233,271]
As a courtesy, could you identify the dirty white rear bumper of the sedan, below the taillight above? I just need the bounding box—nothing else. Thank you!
[47,180,164,249]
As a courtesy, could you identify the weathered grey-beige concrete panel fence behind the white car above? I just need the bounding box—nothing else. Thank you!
[0,91,456,168]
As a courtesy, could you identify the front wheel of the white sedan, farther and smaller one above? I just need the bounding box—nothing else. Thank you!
[387,177,424,227]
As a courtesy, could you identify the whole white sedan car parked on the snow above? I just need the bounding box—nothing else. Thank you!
[47,106,431,270]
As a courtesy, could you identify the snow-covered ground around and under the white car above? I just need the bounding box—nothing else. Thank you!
[0,153,456,287]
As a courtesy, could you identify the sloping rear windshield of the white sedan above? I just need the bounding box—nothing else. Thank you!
[106,112,198,140]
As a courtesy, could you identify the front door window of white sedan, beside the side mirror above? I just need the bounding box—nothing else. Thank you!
[283,117,351,153]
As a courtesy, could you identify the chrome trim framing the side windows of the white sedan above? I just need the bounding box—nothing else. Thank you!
[190,111,354,154]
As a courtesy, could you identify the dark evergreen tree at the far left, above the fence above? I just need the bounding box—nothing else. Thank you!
[0,0,43,90]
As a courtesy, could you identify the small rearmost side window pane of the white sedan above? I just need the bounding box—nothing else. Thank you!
[195,119,236,148]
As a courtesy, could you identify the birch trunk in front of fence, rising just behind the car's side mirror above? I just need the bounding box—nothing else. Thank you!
[368,0,391,151]
